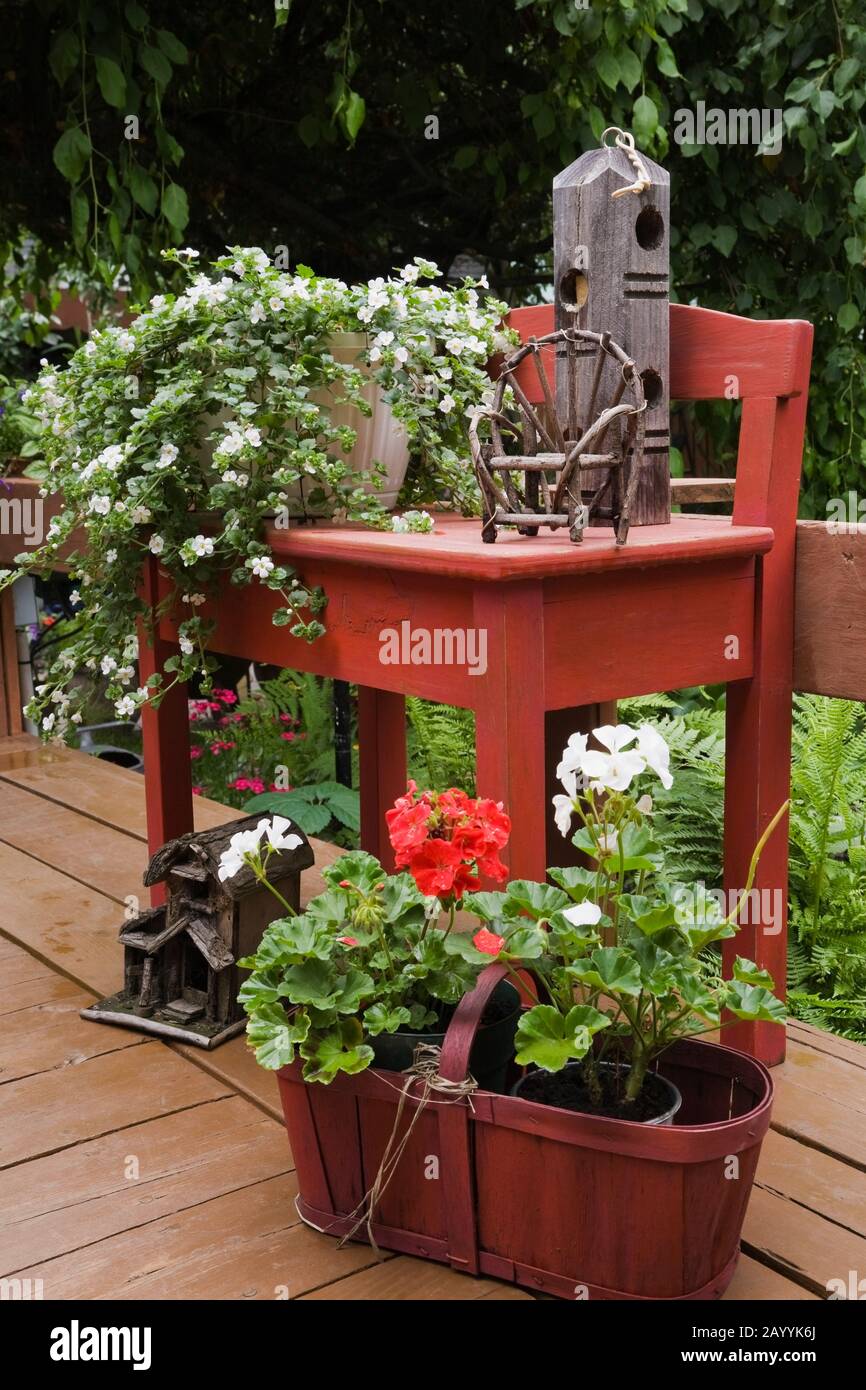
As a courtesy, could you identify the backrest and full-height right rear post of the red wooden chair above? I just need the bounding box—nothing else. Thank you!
[510,304,812,1062]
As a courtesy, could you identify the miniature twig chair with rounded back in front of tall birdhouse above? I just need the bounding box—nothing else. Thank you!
[468,328,646,545]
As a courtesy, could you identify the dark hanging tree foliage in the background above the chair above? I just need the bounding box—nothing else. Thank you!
[0,0,866,516]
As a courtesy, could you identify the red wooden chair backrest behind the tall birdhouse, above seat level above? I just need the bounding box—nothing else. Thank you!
[509,304,812,528]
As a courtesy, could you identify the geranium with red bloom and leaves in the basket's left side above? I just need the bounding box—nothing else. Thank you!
[233,788,510,1083]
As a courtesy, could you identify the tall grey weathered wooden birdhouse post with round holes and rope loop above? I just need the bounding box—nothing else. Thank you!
[553,132,670,525]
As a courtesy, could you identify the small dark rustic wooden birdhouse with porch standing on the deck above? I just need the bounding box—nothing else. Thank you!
[82,816,314,1048]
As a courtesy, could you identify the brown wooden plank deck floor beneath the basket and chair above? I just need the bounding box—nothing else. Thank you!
[0,735,866,1300]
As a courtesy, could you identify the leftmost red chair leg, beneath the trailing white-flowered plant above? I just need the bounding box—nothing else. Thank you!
[139,556,193,906]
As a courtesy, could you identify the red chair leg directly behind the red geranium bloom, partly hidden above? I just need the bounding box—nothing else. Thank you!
[357,685,406,873]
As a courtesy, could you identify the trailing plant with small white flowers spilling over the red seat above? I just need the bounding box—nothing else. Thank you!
[0,247,505,737]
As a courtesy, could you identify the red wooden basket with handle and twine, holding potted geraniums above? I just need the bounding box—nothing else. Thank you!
[278,965,773,1298]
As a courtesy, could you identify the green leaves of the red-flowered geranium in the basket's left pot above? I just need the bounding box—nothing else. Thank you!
[239,845,489,1084]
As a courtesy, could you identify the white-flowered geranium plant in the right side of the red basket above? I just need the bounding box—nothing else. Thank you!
[461,724,787,1116]
